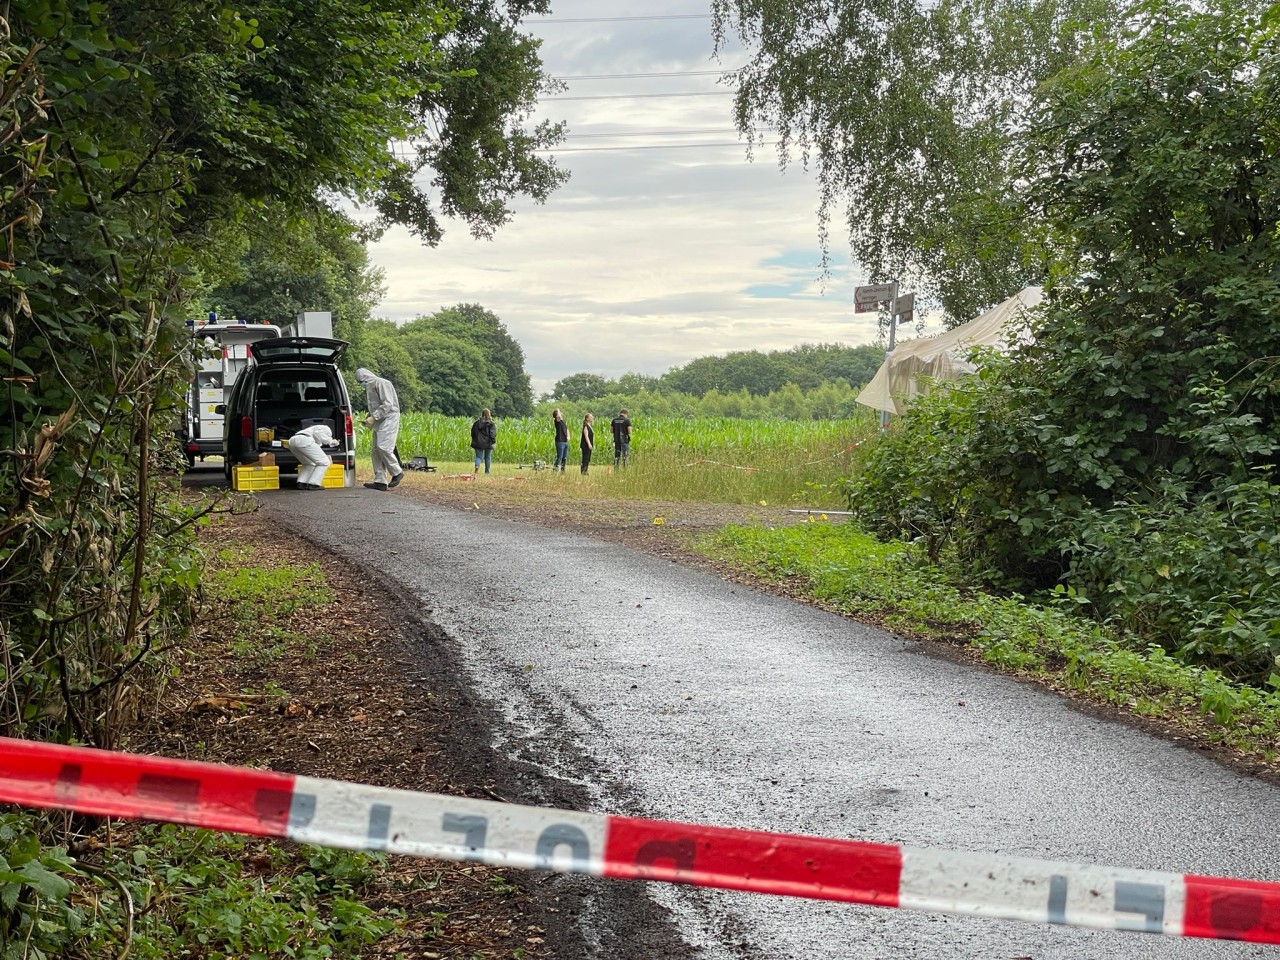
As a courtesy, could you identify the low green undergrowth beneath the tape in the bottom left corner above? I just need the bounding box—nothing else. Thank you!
[0,813,398,960]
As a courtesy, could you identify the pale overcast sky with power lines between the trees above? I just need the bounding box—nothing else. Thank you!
[370,0,877,394]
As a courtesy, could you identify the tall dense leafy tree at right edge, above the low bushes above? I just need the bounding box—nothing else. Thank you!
[1008,0,1280,497]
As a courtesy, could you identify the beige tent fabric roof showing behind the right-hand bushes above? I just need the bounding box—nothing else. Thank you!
[858,287,1043,413]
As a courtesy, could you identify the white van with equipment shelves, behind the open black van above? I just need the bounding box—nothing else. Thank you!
[182,321,280,466]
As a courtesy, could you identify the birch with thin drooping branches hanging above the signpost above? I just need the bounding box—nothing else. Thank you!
[712,0,1125,321]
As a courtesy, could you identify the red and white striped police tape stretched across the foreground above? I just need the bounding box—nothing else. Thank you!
[0,737,1280,943]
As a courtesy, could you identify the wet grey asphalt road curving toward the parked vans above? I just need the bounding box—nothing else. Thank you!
[261,488,1280,960]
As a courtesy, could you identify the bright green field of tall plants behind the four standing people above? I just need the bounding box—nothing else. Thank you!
[358,411,877,508]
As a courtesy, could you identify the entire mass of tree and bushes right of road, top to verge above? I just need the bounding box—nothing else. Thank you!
[850,0,1280,686]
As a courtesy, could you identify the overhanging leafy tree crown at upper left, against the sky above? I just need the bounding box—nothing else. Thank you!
[135,0,564,252]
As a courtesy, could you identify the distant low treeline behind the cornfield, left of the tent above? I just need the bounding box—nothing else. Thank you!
[543,343,884,419]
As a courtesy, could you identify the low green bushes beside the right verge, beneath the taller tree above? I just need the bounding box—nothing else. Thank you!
[842,358,1280,685]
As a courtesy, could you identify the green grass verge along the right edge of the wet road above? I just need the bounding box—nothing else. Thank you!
[698,517,1280,772]
